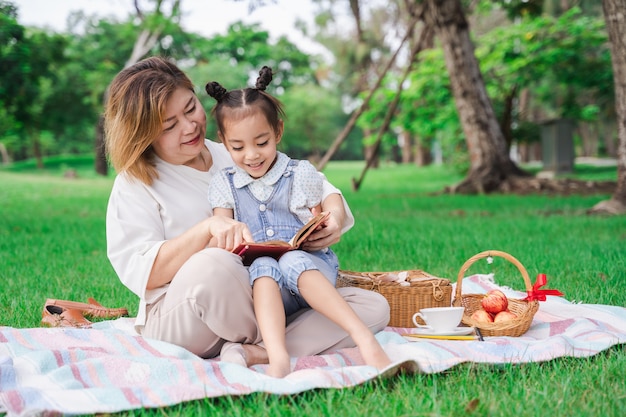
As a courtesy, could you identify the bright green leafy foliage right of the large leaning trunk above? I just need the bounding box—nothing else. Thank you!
[476,8,613,120]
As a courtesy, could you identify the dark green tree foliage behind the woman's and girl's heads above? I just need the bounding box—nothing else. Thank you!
[0,2,326,160]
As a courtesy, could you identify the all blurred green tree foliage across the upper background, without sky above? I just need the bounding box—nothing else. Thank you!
[0,0,614,172]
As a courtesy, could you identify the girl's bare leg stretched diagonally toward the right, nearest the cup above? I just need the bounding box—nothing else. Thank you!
[298,270,391,369]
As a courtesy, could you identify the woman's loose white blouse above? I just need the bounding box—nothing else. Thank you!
[106,140,354,330]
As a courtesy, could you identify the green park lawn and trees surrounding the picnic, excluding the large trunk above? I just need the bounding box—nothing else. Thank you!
[0,0,626,416]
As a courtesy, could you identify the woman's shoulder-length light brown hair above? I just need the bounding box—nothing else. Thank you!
[104,57,194,185]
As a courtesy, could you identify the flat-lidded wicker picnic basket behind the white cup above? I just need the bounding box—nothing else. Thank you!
[337,270,452,327]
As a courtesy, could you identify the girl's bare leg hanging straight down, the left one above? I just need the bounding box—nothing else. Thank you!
[252,277,291,378]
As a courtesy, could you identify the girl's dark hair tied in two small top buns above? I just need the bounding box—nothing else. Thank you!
[205,66,285,134]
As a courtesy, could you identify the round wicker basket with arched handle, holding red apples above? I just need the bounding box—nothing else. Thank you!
[454,250,539,337]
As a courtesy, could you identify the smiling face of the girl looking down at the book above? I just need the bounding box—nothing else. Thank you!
[219,111,283,178]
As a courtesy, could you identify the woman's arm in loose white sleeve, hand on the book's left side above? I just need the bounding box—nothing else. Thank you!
[106,175,251,294]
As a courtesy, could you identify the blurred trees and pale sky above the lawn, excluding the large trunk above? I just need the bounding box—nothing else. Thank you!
[0,0,618,180]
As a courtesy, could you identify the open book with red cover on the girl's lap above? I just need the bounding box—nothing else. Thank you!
[232,211,330,266]
